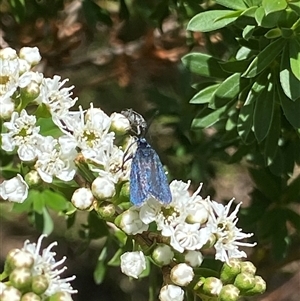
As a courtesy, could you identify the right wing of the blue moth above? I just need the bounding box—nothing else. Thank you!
[148,148,172,204]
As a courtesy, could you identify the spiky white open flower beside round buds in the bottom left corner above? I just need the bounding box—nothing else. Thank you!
[21,235,77,296]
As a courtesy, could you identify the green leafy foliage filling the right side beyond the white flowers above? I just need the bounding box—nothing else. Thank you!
[182,0,300,260]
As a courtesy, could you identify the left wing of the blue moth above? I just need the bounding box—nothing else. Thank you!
[130,147,149,206]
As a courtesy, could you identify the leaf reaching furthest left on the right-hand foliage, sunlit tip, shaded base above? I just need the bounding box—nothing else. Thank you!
[182,53,228,79]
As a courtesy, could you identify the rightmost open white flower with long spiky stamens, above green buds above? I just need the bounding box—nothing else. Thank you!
[207,199,256,264]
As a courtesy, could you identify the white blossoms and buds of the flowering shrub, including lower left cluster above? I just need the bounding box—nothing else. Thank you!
[0,48,265,301]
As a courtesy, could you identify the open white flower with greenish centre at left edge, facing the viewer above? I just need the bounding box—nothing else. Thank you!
[1,110,40,161]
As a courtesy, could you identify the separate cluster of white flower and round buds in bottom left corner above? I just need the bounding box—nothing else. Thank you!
[0,235,77,301]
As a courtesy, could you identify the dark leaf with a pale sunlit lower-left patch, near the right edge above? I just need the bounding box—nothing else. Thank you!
[280,46,300,100]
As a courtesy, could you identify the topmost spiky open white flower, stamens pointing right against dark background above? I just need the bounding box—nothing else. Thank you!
[36,75,77,126]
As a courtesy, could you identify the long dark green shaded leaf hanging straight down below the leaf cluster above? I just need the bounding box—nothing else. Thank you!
[253,81,274,142]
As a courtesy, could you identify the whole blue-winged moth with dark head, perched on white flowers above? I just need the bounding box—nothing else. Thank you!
[121,109,172,206]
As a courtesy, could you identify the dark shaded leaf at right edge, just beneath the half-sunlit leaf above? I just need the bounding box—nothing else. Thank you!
[278,87,300,128]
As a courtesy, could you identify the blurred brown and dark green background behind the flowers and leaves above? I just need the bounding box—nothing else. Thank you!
[0,0,300,301]
